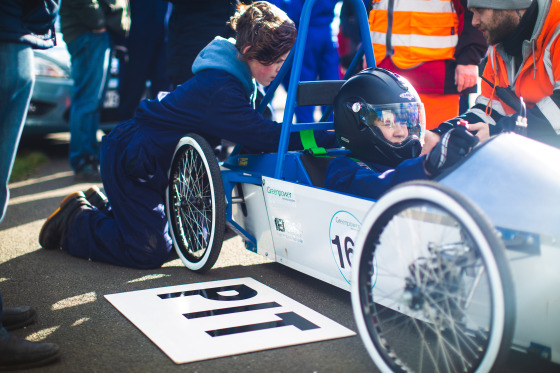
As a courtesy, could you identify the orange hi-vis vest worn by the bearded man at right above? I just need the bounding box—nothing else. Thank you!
[477,0,560,132]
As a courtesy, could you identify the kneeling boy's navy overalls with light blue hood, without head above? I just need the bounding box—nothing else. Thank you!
[62,38,338,268]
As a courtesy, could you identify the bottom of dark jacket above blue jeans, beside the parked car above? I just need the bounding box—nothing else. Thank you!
[60,0,130,44]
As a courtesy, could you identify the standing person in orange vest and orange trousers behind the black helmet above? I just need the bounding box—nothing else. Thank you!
[369,0,488,130]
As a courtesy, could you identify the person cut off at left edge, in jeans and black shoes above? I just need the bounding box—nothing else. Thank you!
[0,0,60,371]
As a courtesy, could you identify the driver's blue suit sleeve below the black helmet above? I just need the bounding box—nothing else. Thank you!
[325,156,428,200]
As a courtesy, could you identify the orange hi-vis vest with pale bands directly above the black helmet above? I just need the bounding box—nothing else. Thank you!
[369,0,460,69]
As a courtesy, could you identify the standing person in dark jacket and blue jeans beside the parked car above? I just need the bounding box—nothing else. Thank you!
[60,0,130,182]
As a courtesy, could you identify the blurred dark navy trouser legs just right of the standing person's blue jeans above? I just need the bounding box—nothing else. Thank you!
[119,0,171,121]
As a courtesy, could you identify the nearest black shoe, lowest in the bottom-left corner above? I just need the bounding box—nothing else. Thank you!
[0,333,60,371]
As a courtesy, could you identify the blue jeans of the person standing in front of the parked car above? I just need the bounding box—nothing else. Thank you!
[67,32,111,171]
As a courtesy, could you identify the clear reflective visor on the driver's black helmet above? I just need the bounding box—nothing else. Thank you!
[351,102,426,144]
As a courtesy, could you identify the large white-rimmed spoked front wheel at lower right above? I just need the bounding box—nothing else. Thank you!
[352,182,515,372]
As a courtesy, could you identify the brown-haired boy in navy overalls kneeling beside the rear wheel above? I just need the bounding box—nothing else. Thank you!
[39,1,338,269]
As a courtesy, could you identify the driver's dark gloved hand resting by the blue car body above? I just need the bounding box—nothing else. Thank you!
[424,126,478,178]
